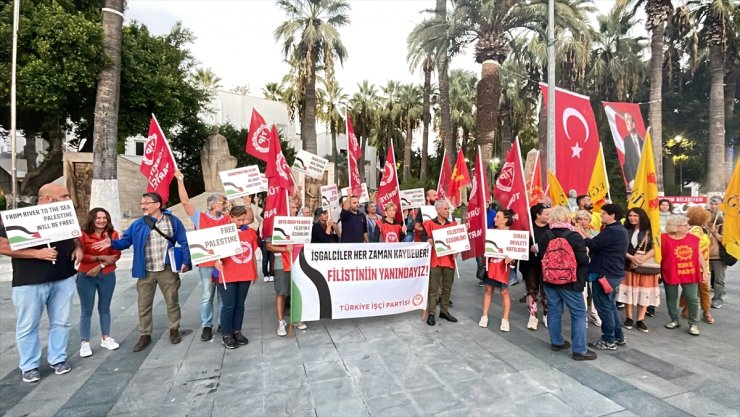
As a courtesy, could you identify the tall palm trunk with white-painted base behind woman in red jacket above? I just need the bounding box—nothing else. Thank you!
[90,0,124,230]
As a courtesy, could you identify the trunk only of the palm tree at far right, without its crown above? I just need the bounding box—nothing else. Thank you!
[707,43,727,192]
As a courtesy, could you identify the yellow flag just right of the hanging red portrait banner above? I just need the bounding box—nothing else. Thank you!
[628,130,662,262]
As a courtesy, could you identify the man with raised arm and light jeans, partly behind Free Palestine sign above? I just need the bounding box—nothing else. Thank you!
[175,170,231,342]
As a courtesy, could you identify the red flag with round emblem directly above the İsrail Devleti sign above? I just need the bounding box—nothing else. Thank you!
[493,137,530,230]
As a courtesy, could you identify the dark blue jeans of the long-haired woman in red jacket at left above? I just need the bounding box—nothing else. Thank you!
[77,271,116,341]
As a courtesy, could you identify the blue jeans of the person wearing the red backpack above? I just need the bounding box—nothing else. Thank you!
[544,285,588,354]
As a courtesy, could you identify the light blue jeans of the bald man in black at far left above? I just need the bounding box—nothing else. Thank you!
[13,275,75,372]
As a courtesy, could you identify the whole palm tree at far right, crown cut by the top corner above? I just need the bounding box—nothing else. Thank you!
[688,0,740,192]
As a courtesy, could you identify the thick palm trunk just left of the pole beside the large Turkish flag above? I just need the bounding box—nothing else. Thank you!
[475,60,501,182]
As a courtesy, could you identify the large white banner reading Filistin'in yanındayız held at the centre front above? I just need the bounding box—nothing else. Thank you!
[290,242,431,323]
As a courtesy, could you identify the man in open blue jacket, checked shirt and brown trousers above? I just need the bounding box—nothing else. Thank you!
[93,193,191,352]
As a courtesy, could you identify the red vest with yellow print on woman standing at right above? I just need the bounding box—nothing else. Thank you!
[660,233,702,285]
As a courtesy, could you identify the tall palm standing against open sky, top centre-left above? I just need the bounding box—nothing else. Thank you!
[274,0,350,154]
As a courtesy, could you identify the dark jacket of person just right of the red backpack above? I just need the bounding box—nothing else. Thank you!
[586,222,628,278]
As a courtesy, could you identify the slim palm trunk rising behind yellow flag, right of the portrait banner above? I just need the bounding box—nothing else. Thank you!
[650,18,665,190]
